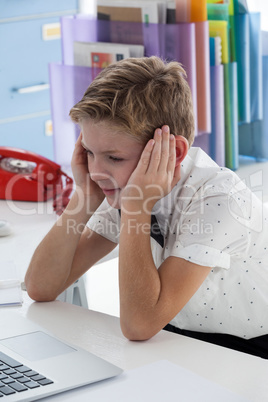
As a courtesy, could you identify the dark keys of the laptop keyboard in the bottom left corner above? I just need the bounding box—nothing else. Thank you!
[0,352,53,398]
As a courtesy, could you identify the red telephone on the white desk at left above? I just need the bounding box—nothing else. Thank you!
[0,147,73,214]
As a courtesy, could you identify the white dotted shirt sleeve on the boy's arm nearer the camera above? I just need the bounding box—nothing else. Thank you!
[171,186,254,269]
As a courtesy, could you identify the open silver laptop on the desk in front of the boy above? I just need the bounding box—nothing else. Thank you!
[0,309,122,402]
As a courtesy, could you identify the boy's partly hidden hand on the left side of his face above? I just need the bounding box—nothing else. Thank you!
[71,133,104,208]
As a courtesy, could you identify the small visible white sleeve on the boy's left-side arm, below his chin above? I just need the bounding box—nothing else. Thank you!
[87,199,120,243]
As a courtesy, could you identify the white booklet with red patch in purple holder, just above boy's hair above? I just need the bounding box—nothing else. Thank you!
[74,42,144,68]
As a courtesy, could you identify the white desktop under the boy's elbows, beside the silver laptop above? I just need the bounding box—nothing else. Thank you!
[8,293,268,402]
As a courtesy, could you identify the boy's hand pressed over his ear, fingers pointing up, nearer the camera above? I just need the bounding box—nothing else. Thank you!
[121,126,180,214]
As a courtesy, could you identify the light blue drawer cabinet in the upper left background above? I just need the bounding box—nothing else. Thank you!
[0,0,78,159]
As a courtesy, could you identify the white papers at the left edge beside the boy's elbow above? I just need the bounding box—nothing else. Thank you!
[0,261,22,306]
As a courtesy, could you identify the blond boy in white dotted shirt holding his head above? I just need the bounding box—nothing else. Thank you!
[25,57,268,358]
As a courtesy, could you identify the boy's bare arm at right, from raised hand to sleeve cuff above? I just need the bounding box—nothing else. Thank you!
[119,130,211,340]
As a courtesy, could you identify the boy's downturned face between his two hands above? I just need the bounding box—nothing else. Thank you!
[81,119,144,208]
